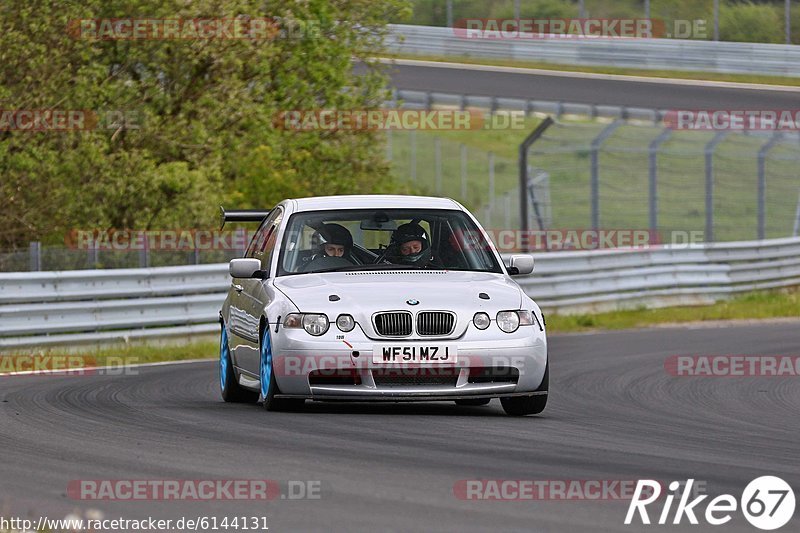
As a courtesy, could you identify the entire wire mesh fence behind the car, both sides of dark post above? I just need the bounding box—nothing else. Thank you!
[387,112,800,242]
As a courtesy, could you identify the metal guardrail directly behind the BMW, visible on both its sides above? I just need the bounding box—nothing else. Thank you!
[0,238,800,350]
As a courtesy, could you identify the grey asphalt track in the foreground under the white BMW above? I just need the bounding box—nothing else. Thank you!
[0,322,800,533]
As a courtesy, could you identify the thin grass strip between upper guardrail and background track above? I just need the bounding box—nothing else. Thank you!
[384,54,800,87]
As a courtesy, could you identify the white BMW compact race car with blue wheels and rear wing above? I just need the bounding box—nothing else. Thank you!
[219,195,549,415]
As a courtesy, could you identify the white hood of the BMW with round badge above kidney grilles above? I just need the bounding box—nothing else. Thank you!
[274,270,522,333]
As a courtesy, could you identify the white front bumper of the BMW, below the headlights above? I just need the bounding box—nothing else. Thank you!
[272,326,547,401]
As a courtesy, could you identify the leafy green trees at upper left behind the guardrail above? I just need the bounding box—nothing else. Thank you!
[0,0,406,247]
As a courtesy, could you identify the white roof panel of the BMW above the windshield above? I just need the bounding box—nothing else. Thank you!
[292,194,462,211]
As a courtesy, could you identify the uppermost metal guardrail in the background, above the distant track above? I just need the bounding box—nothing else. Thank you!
[386,24,800,76]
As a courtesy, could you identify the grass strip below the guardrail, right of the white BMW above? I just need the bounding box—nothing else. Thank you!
[547,289,800,333]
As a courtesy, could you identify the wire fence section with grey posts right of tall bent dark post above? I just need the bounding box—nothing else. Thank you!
[530,121,800,242]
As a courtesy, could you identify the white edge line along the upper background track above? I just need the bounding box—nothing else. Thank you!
[376,57,800,93]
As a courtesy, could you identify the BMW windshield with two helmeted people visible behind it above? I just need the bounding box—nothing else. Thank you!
[278,209,502,276]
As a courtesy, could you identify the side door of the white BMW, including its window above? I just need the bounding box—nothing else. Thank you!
[237,207,283,377]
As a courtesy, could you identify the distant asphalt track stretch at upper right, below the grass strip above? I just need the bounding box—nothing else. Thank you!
[378,60,800,110]
